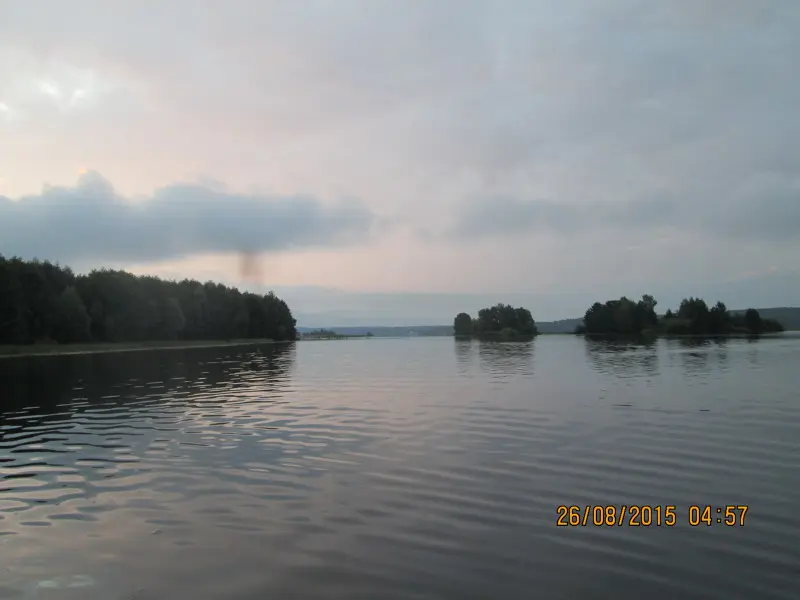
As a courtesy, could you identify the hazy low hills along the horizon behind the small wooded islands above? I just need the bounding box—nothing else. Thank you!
[297,306,800,337]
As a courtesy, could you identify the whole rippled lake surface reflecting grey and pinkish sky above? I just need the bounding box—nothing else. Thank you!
[0,336,800,600]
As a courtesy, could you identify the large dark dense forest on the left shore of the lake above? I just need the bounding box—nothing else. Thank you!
[0,255,297,344]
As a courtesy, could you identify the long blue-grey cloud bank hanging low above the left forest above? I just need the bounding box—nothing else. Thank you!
[0,172,375,262]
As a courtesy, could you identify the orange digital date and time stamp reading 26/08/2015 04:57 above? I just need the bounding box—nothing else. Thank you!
[556,504,748,527]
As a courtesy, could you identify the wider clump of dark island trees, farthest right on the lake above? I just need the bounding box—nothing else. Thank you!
[575,295,783,336]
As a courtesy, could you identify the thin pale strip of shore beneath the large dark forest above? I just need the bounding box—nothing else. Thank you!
[0,339,278,358]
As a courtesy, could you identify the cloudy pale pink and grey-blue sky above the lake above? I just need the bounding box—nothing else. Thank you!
[0,0,800,326]
